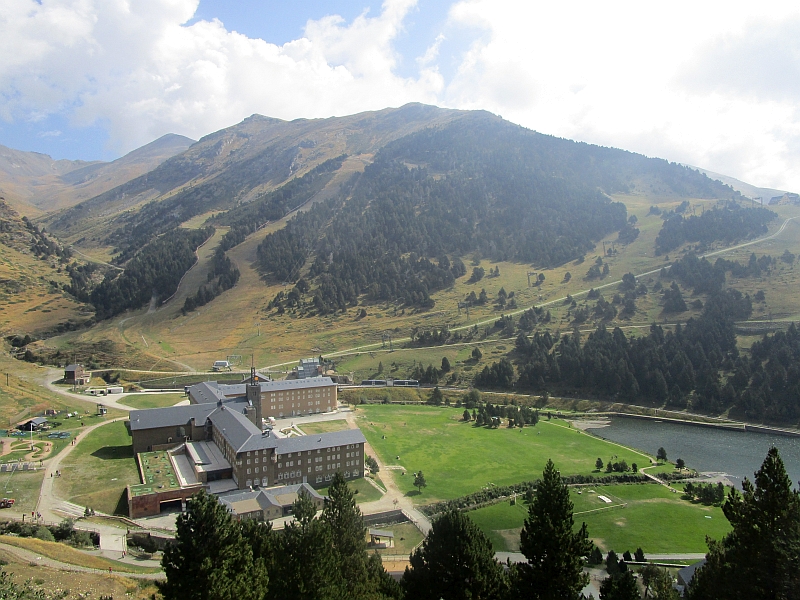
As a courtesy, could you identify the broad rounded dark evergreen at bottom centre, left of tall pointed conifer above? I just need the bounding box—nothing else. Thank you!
[402,510,508,600]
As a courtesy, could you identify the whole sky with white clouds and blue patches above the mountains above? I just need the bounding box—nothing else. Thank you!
[0,0,800,192]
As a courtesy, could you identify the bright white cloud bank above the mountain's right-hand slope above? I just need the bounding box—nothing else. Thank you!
[447,0,800,190]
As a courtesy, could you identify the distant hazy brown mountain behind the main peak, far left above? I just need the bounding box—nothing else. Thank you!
[0,134,194,216]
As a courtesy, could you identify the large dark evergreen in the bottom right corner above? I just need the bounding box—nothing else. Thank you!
[689,447,800,600]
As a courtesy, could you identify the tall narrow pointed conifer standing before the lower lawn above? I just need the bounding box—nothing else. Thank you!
[513,460,592,600]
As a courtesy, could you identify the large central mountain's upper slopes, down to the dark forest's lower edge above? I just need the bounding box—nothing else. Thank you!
[46,104,739,326]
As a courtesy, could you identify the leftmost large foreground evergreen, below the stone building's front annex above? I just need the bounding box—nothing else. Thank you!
[157,491,267,600]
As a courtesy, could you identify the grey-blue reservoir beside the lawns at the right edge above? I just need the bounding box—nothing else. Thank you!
[588,417,800,489]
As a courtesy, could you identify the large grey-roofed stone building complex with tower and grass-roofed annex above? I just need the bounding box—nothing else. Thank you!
[128,373,366,517]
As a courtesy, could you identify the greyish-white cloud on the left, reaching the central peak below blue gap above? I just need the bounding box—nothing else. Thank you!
[0,0,442,151]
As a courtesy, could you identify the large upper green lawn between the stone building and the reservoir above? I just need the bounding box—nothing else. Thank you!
[356,405,649,503]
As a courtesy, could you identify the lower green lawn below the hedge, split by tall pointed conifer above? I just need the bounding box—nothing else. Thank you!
[469,484,730,554]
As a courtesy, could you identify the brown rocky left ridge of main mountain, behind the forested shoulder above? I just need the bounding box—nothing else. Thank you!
[46,104,474,252]
